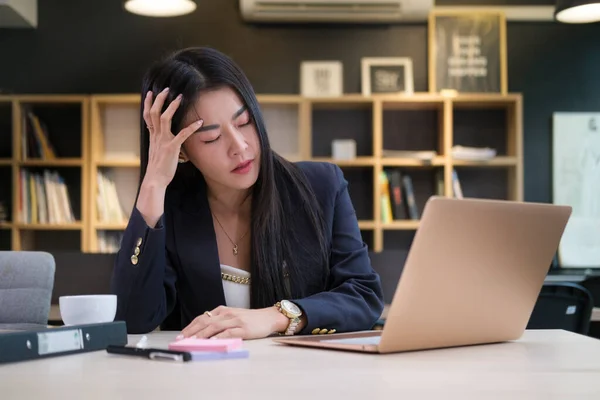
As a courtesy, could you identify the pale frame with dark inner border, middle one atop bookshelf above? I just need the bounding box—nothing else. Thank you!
[361,57,414,96]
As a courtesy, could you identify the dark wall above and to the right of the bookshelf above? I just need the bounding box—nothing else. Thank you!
[0,0,600,201]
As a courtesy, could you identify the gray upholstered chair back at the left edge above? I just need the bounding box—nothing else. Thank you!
[0,251,56,329]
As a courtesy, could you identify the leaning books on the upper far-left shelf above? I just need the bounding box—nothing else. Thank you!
[21,109,56,160]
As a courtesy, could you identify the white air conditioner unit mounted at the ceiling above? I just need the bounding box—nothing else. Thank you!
[240,0,434,24]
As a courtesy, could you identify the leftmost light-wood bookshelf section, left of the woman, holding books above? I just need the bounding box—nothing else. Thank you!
[0,95,89,251]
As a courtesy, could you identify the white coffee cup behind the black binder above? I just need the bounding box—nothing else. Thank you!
[58,294,117,325]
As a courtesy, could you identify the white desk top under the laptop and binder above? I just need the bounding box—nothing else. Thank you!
[0,331,600,400]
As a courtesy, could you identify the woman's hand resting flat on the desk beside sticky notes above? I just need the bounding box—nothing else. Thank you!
[179,306,304,339]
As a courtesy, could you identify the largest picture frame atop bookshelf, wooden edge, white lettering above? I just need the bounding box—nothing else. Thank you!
[428,10,508,94]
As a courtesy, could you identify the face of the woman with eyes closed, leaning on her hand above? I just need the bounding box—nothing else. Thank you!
[182,87,260,190]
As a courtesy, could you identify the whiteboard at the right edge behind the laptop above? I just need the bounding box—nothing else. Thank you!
[552,112,600,268]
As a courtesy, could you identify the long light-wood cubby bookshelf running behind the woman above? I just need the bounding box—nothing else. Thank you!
[0,93,523,252]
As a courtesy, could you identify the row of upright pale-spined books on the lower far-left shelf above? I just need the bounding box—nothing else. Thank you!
[19,169,75,224]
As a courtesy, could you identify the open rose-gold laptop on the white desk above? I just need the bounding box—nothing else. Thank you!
[273,196,571,353]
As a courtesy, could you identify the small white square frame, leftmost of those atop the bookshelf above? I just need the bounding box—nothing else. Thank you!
[300,61,344,97]
